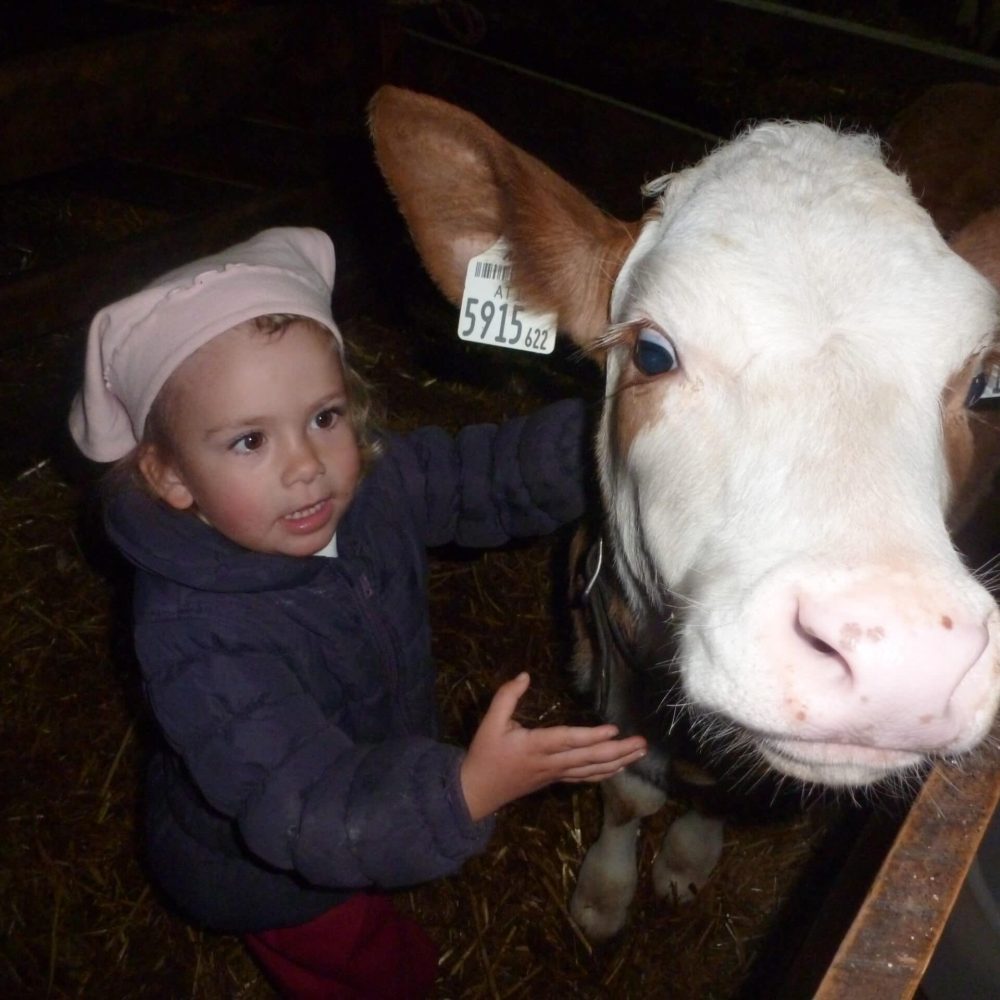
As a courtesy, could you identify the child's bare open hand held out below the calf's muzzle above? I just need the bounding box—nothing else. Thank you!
[461,674,646,820]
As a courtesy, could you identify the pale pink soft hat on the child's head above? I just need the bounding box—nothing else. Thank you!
[69,228,344,462]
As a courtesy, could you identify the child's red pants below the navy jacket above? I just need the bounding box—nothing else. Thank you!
[243,893,437,1000]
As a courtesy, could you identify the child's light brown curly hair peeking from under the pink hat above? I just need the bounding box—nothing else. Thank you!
[108,313,384,490]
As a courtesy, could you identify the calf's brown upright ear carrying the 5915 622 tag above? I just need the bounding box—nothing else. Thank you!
[369,86,639,347]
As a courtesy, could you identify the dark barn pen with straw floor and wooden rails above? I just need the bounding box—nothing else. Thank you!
[0,0,1000,1000]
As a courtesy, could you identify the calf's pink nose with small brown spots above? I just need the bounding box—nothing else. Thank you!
[786,583,989,750]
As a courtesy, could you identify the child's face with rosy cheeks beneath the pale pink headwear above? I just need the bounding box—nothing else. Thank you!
[140,322,361,556]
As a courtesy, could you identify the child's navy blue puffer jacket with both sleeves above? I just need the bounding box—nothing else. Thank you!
[105,401,585,933]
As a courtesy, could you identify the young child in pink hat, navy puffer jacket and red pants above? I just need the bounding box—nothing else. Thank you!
[70,228,644,998]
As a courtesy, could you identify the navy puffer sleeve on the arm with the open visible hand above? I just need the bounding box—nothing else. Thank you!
[136,616,492,889]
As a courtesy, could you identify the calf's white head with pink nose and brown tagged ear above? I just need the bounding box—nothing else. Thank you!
[371,88,1000,785]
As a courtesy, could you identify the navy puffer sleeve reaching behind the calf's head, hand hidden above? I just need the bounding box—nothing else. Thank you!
[387,399,588,548]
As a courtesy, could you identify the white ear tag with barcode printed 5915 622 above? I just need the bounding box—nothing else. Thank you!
[458,238,558,354]
